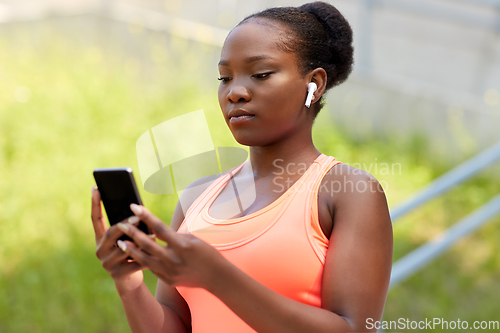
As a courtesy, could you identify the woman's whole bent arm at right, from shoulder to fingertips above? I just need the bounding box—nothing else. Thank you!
[121,169,392,333]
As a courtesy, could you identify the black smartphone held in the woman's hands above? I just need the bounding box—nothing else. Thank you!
[94,167,150,240]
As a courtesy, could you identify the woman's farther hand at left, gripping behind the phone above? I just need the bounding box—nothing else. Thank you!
[91,188,145,295]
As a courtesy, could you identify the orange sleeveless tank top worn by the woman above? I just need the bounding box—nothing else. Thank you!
[177,154,340,333]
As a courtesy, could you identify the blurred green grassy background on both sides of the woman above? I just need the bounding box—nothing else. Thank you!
[0,0,500,332]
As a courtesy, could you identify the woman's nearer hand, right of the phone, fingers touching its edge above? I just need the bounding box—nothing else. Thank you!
[118,204,229,289]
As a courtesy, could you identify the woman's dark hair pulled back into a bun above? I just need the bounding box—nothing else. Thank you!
[238,1,354,113]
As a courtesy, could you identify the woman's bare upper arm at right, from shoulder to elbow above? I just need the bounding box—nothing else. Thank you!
[322,165,393,332]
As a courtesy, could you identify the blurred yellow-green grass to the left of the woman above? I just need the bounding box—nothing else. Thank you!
[0,26,230,332]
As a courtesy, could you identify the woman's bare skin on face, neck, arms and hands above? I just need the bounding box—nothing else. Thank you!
[92,20,392,333]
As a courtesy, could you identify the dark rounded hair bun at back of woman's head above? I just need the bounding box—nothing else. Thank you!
[298,1,354,86]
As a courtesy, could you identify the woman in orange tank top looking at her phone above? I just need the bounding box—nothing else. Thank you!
[92,2,392,333]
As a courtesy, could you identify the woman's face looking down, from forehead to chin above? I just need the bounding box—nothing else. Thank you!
[219,21,313,146]
